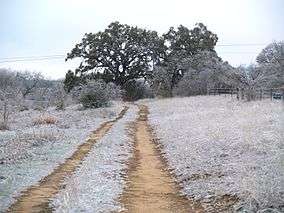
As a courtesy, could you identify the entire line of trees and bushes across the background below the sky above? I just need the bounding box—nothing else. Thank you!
[0,22,284,129]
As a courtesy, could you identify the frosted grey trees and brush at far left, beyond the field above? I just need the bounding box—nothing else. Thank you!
[0,68,66,130]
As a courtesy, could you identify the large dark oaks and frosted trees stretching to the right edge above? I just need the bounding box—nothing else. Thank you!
[64,22,284,100]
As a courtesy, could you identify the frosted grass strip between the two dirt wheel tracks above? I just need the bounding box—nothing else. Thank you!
[52,106,138,212]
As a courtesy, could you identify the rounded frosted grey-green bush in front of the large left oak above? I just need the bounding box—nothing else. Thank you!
[73,80,121,108]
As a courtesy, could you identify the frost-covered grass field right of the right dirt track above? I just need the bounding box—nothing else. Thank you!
[144,96,284,212]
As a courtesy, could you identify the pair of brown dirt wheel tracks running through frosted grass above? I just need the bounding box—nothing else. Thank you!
[8,106,204,213]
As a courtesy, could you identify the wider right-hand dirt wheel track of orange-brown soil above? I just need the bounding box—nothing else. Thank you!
[121,106,204,213]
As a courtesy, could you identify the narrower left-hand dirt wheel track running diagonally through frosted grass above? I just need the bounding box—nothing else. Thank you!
[8,106,128,212]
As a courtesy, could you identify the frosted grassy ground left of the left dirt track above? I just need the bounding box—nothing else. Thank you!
[0,102,123,212]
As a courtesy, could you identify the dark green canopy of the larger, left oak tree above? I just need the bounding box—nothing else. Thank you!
[66,22,165,86]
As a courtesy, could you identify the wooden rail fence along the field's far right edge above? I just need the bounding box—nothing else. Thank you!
[207,88,284,101]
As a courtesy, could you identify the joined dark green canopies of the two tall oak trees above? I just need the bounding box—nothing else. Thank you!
[65,22,218,91]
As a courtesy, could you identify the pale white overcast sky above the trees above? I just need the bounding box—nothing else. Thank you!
[0,0,284,79]
